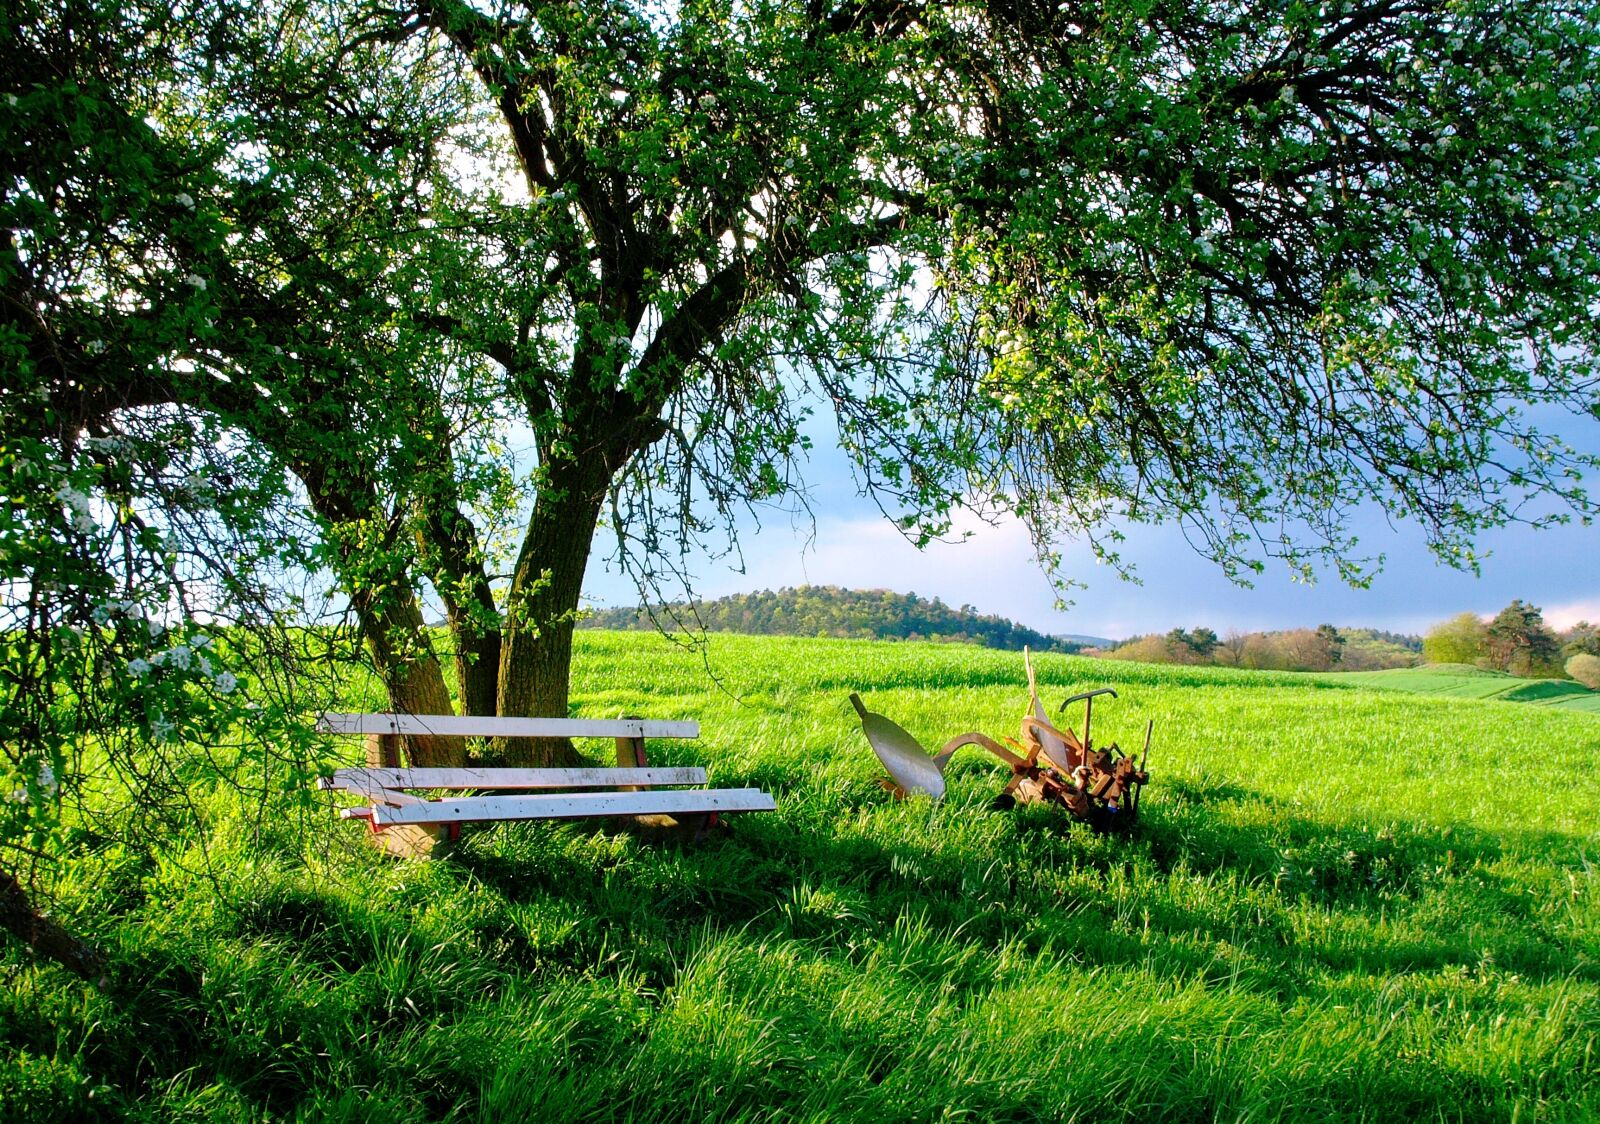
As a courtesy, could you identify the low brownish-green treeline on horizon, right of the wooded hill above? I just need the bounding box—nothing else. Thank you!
[1104,624,1422,671]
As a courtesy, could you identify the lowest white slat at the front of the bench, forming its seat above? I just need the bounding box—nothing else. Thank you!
[371,788,778,828]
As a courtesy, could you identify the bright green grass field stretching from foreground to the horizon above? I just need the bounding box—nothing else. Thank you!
[0,632,1600,1121]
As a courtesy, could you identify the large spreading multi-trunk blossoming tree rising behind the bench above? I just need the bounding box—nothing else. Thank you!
[12,0,1600,784]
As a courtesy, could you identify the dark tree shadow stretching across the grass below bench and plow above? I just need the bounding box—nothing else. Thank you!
[12,777,1600,1114]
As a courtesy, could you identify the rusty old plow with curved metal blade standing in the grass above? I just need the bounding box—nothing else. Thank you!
[850,650,1155,831]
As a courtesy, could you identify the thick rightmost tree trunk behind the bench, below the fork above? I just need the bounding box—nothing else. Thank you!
[499,455,610,765]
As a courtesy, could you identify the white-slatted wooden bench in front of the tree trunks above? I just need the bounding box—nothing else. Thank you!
[317,714,776,857]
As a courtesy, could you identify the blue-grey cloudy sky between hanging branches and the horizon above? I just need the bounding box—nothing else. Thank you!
[584,416,1600,639]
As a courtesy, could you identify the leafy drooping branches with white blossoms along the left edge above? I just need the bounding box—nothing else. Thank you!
[0,3,356,978]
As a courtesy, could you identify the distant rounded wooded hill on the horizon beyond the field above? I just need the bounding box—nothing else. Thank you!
[579,586,1083,652]
